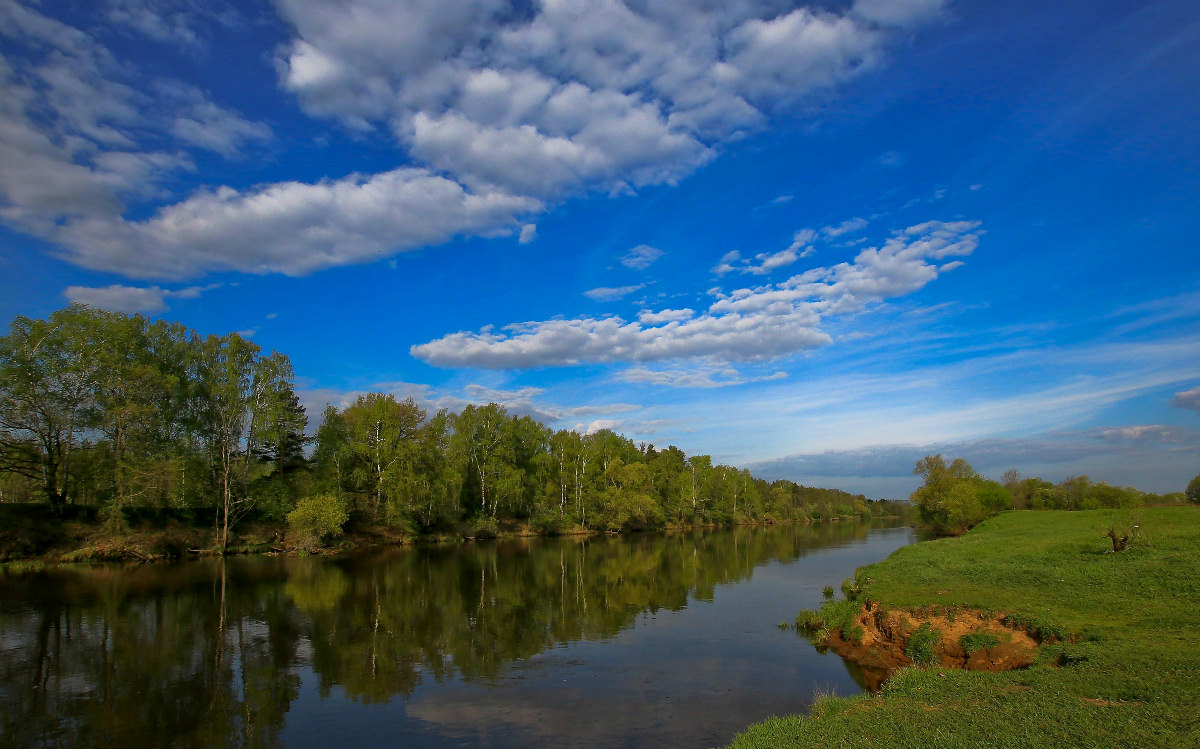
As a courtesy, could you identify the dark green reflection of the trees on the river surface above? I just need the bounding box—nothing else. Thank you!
[0,523,907,747]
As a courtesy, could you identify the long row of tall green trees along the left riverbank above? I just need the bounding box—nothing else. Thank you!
[0,305,906,545]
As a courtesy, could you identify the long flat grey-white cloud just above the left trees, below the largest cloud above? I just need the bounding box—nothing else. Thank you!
[55,168,540,278]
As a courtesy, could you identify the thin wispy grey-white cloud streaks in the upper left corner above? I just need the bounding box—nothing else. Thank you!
[0,1,278,267]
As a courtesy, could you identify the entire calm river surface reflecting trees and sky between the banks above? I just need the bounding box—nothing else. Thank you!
[0,523,914,747]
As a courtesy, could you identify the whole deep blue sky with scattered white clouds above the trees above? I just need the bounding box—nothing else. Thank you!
[0,0,1200,498]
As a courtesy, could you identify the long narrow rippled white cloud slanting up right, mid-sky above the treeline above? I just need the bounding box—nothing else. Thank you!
[410,221,979,368]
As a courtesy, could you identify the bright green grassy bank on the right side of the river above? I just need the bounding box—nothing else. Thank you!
[732,508,1200,749]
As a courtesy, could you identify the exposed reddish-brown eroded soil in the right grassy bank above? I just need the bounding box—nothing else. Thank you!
[826,603,1038,691]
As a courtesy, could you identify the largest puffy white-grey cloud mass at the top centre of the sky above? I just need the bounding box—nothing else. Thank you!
[278,0,938,206]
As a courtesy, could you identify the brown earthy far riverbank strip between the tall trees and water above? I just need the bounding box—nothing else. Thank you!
[0,504,904,567]
